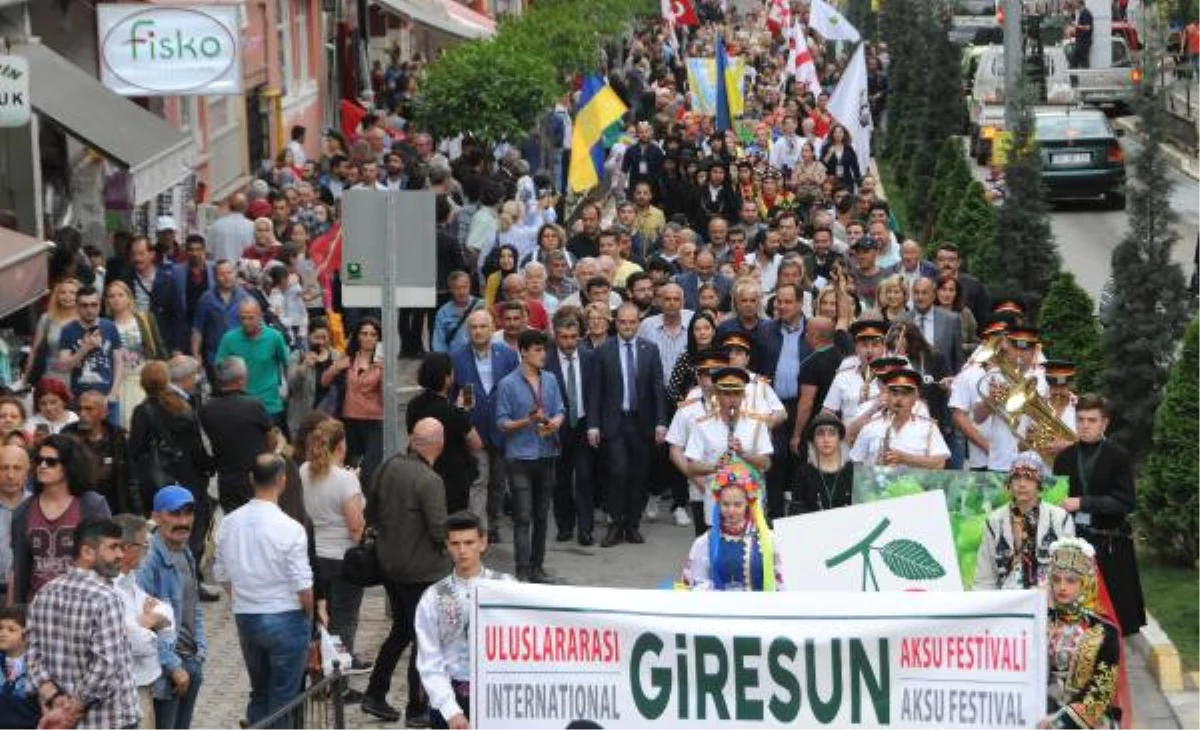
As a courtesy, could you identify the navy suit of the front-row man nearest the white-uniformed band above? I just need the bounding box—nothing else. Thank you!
[588,337,667,532]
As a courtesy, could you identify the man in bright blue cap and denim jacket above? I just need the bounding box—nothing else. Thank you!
[138,484,209,730]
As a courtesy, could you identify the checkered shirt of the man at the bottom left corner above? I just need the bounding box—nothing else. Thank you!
[25,567,138,730]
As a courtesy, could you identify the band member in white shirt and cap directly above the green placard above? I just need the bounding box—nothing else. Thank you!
[850,367,950,469]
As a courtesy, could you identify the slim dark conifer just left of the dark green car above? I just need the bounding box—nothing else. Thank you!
[976,83,1062,311]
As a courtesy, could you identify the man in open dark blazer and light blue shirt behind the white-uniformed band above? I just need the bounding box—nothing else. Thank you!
[750,283,812,520]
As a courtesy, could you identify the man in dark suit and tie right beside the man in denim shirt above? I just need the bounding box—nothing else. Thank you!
[546,312,595,548]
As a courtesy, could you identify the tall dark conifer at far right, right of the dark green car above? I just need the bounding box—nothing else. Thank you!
[1104,68,1187,460]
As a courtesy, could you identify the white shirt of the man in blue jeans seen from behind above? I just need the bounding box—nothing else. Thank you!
[212,498,312,614]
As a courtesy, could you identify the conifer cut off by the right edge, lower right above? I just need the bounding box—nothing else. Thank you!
[1136,318,1200,568]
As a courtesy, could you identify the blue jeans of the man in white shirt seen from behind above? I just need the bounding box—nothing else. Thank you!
[234,610,312,725]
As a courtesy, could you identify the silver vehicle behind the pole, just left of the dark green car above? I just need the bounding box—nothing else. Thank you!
[967,46,1075,164]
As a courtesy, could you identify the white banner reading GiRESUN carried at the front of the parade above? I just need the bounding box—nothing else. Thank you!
[470,581,1046,730]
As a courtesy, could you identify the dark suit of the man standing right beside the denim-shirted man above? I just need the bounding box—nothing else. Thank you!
[546,347,596,537]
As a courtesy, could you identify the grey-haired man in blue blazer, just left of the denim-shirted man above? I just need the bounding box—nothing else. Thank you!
[450,310,517,544]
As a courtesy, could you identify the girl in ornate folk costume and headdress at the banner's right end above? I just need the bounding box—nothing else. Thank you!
[1038,538,1121,730]
